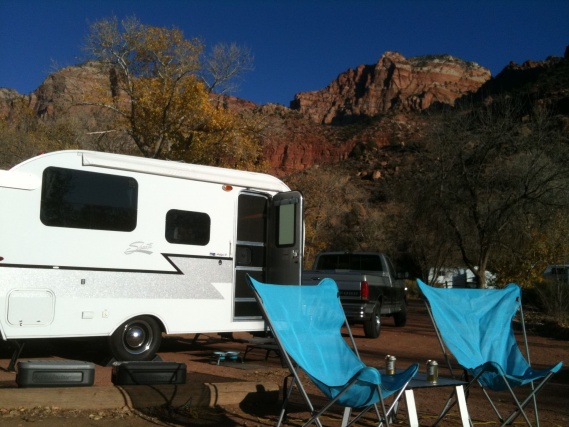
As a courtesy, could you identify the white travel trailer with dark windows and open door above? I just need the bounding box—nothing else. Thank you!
[0,151,304,360]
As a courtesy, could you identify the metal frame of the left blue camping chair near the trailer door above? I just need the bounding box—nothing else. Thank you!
[247,276,418,427]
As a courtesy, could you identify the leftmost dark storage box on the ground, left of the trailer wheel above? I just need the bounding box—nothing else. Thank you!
[16,360,95,387]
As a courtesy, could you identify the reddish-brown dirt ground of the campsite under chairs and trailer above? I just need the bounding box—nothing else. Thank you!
[0,301,569,427]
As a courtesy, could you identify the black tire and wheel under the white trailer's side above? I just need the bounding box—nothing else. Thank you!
[109,316,162,361]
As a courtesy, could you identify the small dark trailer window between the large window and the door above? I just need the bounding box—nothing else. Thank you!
[166,209,211,246]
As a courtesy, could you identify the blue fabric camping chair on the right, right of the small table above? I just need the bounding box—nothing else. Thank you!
[417,279,562,426]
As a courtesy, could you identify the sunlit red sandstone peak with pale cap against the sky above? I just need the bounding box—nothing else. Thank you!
[291,52,491,124]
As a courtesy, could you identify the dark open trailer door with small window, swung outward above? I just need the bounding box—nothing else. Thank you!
[266,191,304,285]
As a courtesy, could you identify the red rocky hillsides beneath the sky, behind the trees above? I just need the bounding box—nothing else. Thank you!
[0,48,569,178]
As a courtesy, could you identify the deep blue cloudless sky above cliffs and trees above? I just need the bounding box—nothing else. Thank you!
[0,0,569,106]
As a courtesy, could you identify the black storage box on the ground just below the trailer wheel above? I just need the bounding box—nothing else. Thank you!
[112,362,186,385]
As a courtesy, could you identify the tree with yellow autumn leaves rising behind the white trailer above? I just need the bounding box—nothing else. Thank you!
[85,18,262,169]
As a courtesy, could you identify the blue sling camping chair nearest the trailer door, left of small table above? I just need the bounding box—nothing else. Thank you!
[247,276,418,426]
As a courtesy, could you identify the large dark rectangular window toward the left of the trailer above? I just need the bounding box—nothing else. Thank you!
[40,167,138,231]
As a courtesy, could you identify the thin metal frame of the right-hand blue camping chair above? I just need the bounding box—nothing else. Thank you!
[417,279,562,427]
